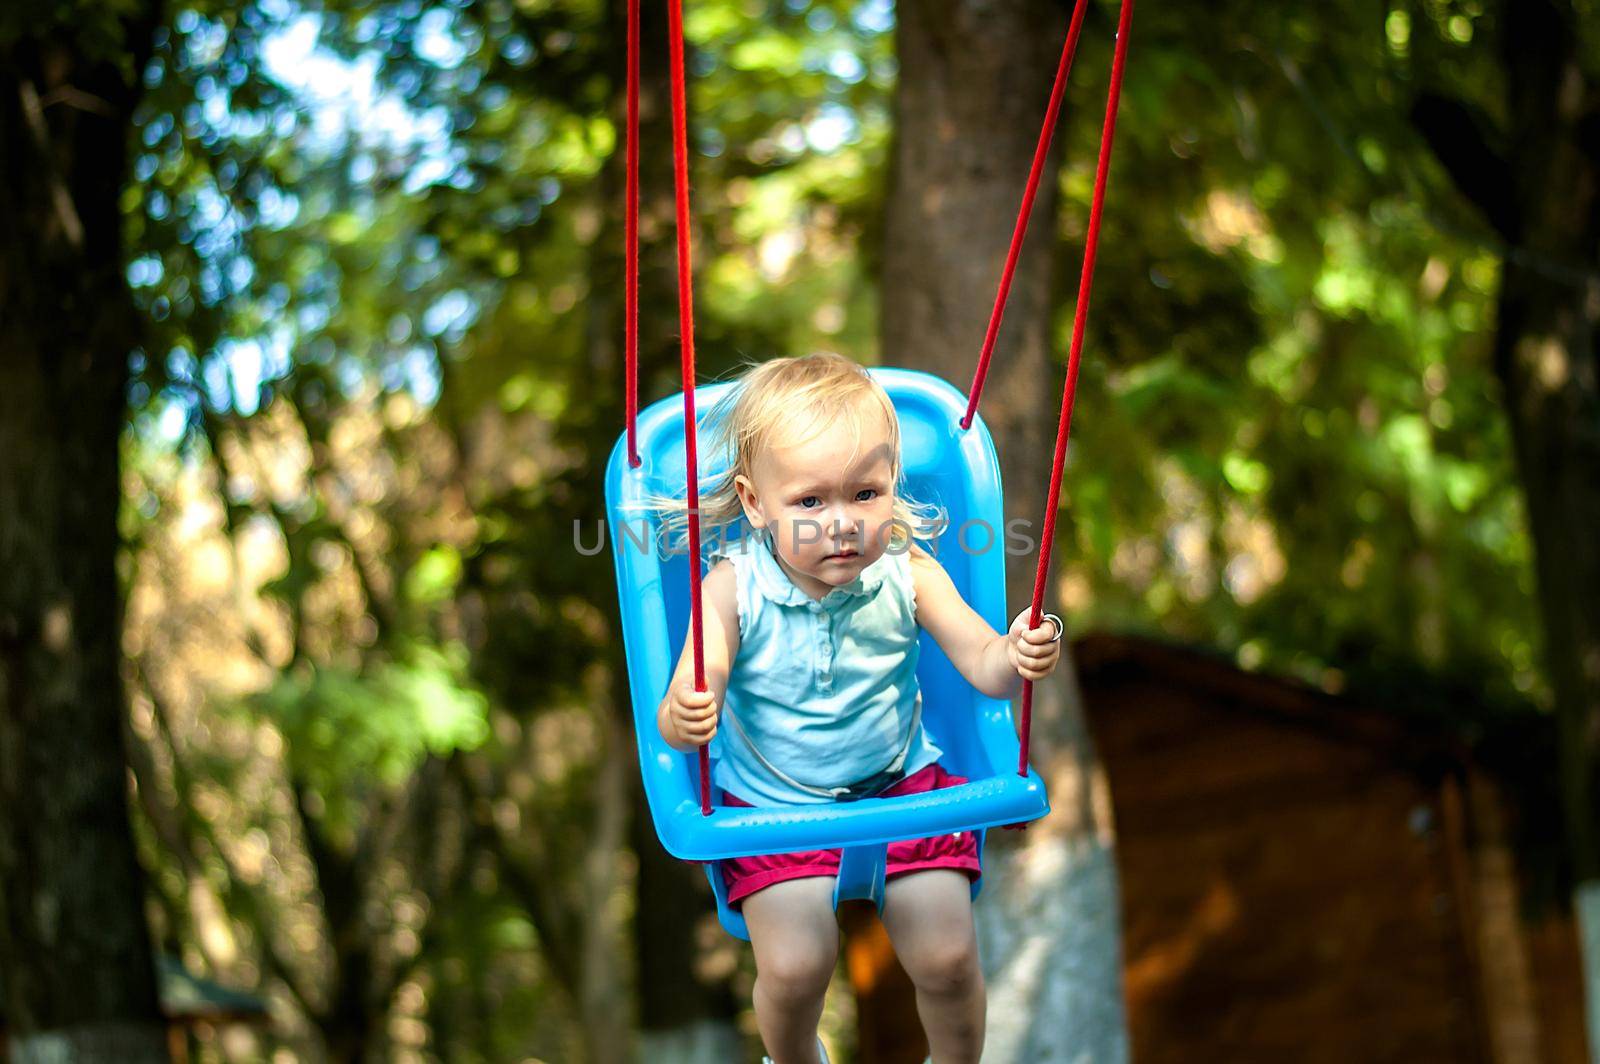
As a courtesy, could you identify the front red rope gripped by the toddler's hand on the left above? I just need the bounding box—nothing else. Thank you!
[667,0,710,816]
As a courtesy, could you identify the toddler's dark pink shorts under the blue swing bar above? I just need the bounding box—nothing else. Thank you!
[722,765,982,907]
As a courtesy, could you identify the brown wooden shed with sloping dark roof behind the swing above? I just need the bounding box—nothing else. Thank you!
[845,637,1589,1064]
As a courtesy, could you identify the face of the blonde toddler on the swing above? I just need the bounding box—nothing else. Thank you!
[734,404,894,598]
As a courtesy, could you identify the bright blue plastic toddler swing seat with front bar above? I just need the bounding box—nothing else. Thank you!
[605,368,1050,939]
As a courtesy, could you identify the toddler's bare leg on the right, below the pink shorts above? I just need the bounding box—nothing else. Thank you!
[883,869,984,1064]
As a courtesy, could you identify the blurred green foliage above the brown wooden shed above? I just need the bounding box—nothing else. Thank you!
[1061,6,1542,699]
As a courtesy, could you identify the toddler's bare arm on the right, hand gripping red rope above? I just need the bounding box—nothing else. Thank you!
[910,544,1061,699]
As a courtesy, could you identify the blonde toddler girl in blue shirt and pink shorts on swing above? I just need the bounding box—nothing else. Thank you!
[643,354,1061,1064]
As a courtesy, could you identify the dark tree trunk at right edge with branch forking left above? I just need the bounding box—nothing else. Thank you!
[1413,0,1600,1036]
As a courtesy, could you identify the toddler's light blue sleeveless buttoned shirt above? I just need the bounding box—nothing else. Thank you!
[710,534,941,805]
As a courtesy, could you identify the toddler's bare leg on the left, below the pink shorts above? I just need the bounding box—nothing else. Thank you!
[742,875,838,1064]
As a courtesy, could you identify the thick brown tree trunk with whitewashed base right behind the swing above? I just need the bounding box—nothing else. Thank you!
[869,0,1128,1064]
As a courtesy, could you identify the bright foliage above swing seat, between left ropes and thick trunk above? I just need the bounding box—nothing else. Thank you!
[685,0,894,365]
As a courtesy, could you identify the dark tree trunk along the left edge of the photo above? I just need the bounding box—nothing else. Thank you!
[0,11,166,1061]
